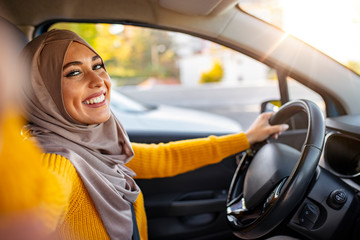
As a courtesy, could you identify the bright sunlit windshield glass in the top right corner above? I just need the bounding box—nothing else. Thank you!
[239,0,360,74]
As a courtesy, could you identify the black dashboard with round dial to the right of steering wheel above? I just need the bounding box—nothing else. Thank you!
[278,115,360,239]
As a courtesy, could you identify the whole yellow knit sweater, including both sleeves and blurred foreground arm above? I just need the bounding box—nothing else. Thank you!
[0,113,249,240]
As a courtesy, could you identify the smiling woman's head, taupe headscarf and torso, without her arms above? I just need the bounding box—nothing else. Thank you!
[23,30,142,239]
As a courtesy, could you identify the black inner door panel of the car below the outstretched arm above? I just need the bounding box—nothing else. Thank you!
[129,132,238,239]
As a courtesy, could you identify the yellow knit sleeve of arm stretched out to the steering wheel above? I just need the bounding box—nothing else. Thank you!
[127,133,250,179]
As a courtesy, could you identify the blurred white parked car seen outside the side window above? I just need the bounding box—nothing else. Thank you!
[111,91,242,136]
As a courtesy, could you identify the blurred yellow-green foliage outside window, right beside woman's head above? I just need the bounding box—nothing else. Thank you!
[52,23,179,85]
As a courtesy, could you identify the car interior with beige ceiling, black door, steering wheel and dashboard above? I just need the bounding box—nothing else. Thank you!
[0,0,360,240]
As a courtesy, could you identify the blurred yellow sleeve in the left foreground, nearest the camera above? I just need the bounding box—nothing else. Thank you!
[0,112,66,232]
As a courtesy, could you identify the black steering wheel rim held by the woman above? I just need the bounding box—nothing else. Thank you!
[227,100,325,239]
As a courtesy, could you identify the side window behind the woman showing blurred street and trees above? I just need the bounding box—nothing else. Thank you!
[51,23,280,132]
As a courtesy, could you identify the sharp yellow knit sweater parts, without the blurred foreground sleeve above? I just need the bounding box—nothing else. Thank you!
[43,133,249,240]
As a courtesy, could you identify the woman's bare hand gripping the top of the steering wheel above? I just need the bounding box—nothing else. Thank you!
[245,112,289,145]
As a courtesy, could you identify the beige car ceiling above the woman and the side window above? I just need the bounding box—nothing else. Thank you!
[0,0,242,48]
